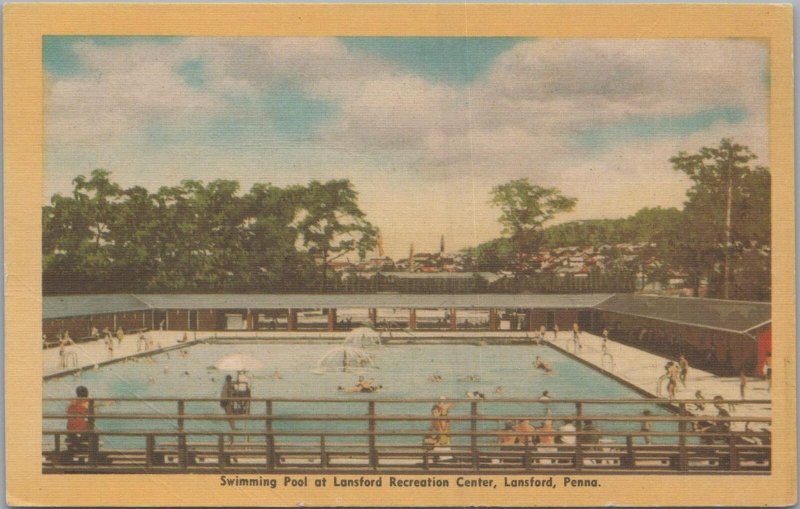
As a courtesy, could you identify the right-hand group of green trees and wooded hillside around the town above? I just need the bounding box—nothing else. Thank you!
[467,139,771,300]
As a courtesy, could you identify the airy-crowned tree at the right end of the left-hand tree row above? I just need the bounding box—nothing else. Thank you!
[290,179,378,293]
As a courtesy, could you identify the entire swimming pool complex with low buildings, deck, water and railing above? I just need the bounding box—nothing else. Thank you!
[42,293,771,474]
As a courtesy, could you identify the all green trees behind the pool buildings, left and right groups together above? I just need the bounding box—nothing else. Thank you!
[42,139,771,300]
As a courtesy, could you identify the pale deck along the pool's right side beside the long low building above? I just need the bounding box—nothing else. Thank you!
[545,331,771,424]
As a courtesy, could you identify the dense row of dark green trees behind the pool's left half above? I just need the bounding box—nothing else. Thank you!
[42,173,378,294]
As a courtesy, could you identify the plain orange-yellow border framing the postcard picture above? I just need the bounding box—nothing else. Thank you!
[3,4,797,506]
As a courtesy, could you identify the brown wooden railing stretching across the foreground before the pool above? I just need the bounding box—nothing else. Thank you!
[42,398,771,474]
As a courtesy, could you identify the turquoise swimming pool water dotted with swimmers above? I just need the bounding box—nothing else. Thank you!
[44,343,676,447]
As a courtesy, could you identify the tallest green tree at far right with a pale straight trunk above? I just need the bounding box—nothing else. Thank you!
[670,138,770,299]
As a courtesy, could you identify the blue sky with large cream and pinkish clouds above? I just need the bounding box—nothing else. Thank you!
[42,36,769,257]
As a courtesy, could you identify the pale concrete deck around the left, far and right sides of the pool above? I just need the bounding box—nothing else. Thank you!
[42,331,771,417]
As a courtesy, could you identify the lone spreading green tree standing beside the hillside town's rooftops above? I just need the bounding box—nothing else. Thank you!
[491,178,578,255]
